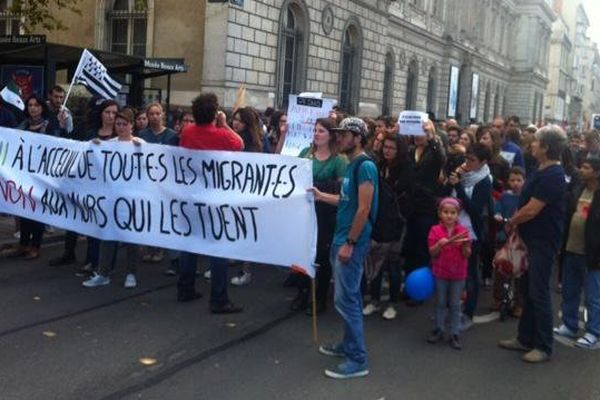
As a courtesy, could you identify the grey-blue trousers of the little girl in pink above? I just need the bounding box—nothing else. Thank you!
[435,278,465,335]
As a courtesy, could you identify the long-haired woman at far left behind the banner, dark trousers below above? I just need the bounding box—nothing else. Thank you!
[12,94,60,260]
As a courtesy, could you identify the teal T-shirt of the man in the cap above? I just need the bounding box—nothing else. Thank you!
[333,156,379,246]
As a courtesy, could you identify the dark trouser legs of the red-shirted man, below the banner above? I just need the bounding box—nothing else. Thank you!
[177,251,230,307]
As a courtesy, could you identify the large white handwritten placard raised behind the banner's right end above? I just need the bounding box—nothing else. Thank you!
[281,94,335,156]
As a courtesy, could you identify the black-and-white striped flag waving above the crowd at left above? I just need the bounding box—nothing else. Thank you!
[73,49,121,99]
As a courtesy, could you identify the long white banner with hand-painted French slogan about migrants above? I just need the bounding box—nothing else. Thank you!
[0,128,317,276]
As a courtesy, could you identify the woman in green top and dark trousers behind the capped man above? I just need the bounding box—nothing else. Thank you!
[291,118,348,313]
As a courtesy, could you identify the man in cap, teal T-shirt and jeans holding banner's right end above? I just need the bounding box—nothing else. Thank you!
[311,117,379,379]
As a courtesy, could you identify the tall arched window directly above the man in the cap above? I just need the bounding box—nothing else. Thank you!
[340,23,361,113]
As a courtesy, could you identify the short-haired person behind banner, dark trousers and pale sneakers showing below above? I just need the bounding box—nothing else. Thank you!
[82,110,145,288]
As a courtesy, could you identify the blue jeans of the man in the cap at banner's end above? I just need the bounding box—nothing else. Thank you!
[331,242,370,366]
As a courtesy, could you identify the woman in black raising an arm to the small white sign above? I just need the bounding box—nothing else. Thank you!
[404,121,445,280]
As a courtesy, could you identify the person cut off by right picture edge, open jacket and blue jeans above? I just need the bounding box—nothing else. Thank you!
[554,157,600,348]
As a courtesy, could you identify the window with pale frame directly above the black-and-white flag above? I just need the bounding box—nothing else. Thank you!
[108,0,148,57]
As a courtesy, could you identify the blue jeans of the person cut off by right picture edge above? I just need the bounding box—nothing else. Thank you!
[562,252,600,337]
